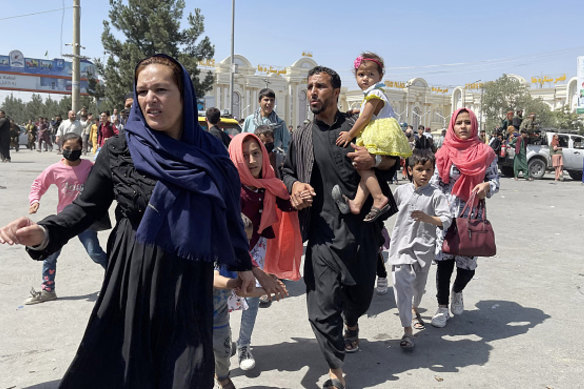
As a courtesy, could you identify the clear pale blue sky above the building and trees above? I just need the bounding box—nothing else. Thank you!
[0,0,584,101]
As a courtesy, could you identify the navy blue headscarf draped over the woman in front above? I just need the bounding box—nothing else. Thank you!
[125,54,251,270]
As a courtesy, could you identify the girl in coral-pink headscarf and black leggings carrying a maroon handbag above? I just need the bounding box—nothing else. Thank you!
[432,108,499,327]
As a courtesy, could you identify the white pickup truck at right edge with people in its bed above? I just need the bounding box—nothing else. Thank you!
[499,129,584,181]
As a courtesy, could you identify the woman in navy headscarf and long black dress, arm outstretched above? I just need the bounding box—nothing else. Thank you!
[0,55,253,389]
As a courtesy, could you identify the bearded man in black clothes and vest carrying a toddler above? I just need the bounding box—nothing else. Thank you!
[282,66,397,389]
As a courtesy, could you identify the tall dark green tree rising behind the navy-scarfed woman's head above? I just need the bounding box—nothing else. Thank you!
[95,0,215,109]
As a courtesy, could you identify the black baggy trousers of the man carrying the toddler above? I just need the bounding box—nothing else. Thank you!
[304,244,377,369]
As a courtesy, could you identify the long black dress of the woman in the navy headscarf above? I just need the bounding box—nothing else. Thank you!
[29,136,251,389]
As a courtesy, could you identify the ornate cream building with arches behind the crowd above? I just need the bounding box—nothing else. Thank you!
[200,55,578,131]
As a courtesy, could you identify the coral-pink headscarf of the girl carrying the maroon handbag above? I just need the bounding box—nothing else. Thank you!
[436,108,497,202]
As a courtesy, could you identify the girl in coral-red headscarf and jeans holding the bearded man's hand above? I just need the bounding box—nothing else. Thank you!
[229,133,302,370]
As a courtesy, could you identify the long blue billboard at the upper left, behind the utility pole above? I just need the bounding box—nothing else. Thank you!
[0,50,97,96]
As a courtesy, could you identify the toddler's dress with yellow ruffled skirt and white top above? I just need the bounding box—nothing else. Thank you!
[357,83,412,158]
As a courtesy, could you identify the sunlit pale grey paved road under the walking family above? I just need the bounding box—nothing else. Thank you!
[0,150,584,389]
